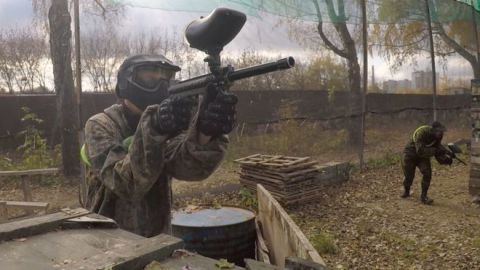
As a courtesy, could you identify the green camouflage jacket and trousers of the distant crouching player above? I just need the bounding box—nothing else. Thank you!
[402,126,442,194]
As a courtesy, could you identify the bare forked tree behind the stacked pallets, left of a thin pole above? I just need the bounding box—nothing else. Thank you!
[277,0,361,147]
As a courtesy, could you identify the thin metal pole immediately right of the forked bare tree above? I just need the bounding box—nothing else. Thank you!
[359,0,368,172]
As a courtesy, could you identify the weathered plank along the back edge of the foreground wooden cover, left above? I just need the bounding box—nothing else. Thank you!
[0,208,89,241]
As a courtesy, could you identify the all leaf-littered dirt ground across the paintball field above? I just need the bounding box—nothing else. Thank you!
[0,125,480,269]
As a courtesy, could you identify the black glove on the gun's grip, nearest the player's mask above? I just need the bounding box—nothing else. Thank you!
[152,97,195,137]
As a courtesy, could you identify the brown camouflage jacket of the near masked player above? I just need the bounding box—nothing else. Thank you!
[85,105,228,237]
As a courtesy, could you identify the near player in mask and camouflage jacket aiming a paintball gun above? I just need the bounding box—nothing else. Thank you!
[82,55,237,237]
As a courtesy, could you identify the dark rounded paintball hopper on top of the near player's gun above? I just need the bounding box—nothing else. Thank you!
[185,8,247,54]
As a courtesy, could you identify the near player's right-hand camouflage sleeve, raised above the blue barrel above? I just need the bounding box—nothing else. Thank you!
[166,131,229,181]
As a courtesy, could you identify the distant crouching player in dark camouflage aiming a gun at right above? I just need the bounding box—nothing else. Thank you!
[401,121,453,204]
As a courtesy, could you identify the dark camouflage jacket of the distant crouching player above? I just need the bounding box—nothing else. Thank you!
[404,125,442,158]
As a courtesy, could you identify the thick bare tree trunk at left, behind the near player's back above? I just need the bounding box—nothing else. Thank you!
[48,0,80,177]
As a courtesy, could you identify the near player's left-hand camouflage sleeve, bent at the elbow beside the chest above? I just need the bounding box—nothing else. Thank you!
[85,107,166,201]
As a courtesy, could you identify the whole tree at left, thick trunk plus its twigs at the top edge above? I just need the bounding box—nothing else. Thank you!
[32,0,121,176]
